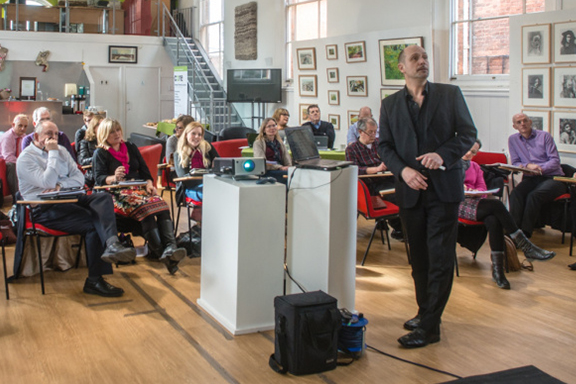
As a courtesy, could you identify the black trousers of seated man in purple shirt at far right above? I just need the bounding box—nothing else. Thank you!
[510,176,566,236]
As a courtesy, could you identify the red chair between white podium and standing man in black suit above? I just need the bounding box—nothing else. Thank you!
[358,179,400,265]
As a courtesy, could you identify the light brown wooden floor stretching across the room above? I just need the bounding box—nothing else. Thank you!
[0,198,576,383]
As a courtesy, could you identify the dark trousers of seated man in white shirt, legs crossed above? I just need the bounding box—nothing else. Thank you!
[32,193,118,277]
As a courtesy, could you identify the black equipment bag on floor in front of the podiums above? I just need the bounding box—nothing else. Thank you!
[269,291,342,375]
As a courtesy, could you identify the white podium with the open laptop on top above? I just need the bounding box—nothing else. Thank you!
[286,166,358,310]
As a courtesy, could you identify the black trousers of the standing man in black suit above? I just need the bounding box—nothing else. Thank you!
[400,185,459,332]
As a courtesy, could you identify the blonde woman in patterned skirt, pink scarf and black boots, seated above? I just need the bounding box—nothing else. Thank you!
[92,119,186,274]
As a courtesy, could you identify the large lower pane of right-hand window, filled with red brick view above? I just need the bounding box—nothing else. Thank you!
[472,18,510,75]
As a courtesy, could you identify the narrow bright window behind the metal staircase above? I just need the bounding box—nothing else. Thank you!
[200,0,224,78]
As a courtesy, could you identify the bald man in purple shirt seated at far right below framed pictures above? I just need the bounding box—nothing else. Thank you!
[508,113,566,237]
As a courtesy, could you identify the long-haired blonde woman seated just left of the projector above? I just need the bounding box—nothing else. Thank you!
[174,121,219,207]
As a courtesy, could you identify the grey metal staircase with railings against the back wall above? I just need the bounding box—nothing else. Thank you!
[162,4,246,133]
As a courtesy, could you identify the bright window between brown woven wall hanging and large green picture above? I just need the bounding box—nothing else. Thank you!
[285,0,327,79]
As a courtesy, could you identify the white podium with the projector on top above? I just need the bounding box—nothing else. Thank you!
[198,175,286,335]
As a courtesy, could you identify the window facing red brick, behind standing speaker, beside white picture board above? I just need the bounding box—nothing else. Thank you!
[451,0,545,76]
